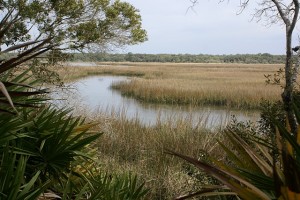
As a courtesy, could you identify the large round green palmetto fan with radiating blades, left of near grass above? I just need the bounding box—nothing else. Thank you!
[14,107,101,184]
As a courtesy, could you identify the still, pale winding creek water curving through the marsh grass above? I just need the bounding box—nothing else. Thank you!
[54,76,259,128]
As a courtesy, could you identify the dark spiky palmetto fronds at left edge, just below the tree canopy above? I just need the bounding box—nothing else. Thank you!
[0,41,47,114]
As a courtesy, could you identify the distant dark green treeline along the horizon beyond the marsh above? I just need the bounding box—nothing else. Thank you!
[68,53,285,64]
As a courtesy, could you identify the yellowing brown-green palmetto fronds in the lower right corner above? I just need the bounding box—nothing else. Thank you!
[168,99,300,200]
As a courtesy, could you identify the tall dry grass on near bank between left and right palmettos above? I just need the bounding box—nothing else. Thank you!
[73,108,222,199]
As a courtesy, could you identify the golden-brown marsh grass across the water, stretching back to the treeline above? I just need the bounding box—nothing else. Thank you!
[56,63,283,109]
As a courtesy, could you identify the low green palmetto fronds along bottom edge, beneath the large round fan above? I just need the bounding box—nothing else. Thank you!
[47,159,149,200]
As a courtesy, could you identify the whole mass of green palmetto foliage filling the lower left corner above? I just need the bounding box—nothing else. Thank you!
[0,65,147,200]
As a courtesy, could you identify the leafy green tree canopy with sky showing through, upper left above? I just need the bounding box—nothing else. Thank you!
[0,0,147,72]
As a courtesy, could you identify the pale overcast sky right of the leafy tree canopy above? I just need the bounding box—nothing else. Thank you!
[124,0,300,54]
